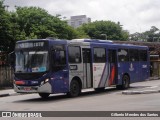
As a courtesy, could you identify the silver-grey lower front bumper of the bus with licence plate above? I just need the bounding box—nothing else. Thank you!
[14,82,52,93]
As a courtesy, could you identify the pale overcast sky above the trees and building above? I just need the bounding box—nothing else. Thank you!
[4,0,160,33]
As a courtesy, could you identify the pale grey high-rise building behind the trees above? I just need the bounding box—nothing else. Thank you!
[67,15,91,28]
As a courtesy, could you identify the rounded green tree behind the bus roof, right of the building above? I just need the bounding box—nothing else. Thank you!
[77,21,129,40]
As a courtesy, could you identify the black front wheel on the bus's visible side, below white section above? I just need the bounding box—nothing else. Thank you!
[67,77,82,97]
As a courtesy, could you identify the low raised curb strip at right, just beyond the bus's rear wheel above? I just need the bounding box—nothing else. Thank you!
[122,90,160,95]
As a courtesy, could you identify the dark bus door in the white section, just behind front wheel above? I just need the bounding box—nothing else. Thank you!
[82,48,93,88]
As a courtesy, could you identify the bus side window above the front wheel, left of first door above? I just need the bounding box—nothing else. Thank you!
[68,46,81,63]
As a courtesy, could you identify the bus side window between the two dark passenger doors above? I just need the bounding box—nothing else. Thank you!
[94,48,106,63]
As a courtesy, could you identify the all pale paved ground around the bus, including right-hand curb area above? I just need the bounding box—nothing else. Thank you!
[0,79,160,120]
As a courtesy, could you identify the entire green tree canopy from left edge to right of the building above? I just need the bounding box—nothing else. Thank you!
[0,0,128,52]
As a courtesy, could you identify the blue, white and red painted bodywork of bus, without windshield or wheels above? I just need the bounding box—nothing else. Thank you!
[14,40,149,93]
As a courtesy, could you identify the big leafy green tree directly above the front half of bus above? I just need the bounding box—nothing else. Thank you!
[16,7,76,39]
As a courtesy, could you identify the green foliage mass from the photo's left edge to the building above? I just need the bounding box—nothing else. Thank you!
[0,0,78,52]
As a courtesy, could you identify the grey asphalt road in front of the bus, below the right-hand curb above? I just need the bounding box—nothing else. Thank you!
[0,81,160,120]
